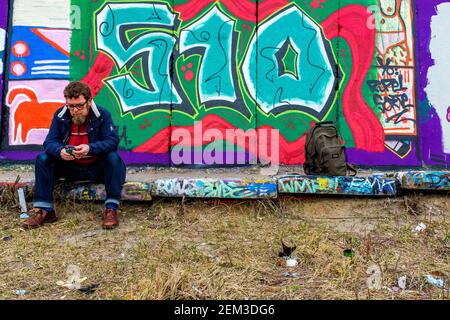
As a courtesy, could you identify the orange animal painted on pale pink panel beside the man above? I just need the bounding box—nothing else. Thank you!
[7,88,62,143]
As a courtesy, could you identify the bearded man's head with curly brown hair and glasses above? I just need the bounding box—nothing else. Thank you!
[64,81,92,125]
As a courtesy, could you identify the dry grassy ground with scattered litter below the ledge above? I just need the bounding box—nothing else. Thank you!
[0,194,450,299]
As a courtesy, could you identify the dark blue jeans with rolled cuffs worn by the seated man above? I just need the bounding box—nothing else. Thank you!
[33,152,126,208]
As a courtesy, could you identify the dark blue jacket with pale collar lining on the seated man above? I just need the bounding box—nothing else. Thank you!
[44,102,119,159]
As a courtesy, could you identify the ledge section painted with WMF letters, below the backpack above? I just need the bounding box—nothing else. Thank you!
[277,175,399,196]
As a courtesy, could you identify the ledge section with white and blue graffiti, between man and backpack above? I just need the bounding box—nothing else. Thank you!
[153,178,277,199]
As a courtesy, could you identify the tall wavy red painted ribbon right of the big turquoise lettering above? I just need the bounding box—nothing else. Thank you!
[322,5,384,152]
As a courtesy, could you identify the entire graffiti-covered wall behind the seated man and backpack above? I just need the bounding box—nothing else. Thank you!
[0,0,450,167]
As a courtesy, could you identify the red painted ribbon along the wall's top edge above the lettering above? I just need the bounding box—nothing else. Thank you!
[174,0,289,22]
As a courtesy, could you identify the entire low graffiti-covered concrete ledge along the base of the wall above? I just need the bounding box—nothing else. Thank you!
[0,171,450,201]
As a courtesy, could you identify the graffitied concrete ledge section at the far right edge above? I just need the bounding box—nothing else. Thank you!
[395,171,450,190]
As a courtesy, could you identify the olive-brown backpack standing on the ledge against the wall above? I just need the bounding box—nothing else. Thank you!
[303,121,356,176]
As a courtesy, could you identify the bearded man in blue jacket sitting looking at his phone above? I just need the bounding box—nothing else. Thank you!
[23,82,126,229]
